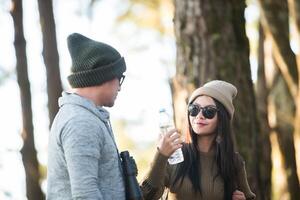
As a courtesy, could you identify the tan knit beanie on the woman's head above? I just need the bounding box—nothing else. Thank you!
[189,80,237,119]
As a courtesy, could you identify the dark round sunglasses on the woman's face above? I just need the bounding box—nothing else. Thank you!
[188,104,218,119]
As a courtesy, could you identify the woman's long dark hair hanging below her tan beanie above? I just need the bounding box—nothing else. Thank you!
[172,99,237,200]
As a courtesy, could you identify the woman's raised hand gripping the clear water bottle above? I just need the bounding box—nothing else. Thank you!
[157,129,183,157]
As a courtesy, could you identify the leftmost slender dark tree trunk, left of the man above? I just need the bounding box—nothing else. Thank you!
[11,0,44,200]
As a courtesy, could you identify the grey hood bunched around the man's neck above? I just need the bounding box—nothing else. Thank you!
[58,92,109,121]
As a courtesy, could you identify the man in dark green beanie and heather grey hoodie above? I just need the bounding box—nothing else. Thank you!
[47,33,126,200]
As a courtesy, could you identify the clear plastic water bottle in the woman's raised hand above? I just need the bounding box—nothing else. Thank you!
[159,109,184,165]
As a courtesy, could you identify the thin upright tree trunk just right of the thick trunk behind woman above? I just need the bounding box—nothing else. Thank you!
[256,25,272,199]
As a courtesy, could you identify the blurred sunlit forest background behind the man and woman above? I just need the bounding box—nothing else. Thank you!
[0,0,300,200]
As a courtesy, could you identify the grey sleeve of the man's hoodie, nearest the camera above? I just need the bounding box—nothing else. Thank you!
[60,116,103,200]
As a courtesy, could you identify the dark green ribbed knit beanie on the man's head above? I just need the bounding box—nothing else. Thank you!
[67,33,126,88]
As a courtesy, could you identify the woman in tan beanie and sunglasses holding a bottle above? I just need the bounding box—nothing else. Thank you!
[141,80,255,200]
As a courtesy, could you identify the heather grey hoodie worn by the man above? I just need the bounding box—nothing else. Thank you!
[47,92,125,200]
